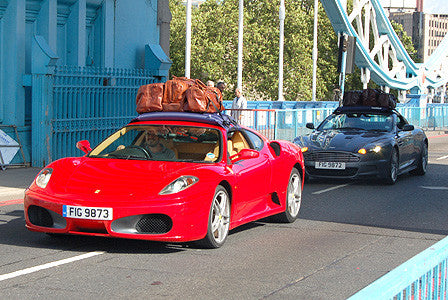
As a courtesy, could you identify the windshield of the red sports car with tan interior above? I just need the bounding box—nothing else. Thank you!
[88,125,222,162]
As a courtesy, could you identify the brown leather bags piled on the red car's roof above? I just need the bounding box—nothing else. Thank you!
[136,77,224,114]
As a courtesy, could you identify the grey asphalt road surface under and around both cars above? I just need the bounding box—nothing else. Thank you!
[0,136,448,299]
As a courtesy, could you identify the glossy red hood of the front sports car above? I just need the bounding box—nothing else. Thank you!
[37,157,215,200]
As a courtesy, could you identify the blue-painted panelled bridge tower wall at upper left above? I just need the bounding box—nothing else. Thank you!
[0,0,171,165]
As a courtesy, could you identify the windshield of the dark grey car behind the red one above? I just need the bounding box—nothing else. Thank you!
[318,112,393,131]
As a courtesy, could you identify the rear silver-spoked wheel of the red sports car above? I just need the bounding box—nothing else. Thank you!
[278,169,302,223]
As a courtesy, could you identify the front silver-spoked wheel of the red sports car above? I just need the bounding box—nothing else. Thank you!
[199,185,230,249]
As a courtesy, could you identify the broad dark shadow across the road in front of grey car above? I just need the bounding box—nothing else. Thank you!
[299,164,448,235]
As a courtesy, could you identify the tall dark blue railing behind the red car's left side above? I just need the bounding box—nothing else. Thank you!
[32,67,159,166]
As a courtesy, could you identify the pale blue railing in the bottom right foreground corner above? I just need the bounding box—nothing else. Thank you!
[349,237,448,300]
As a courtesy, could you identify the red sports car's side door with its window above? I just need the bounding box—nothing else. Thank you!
[228,130,271,220]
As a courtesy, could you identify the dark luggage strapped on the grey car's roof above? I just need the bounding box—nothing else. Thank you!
[342,89,397,109]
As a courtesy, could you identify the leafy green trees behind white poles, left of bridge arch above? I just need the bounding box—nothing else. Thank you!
[170,0,338,100]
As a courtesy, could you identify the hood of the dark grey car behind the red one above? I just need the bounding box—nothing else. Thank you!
[297,130,391,152]
